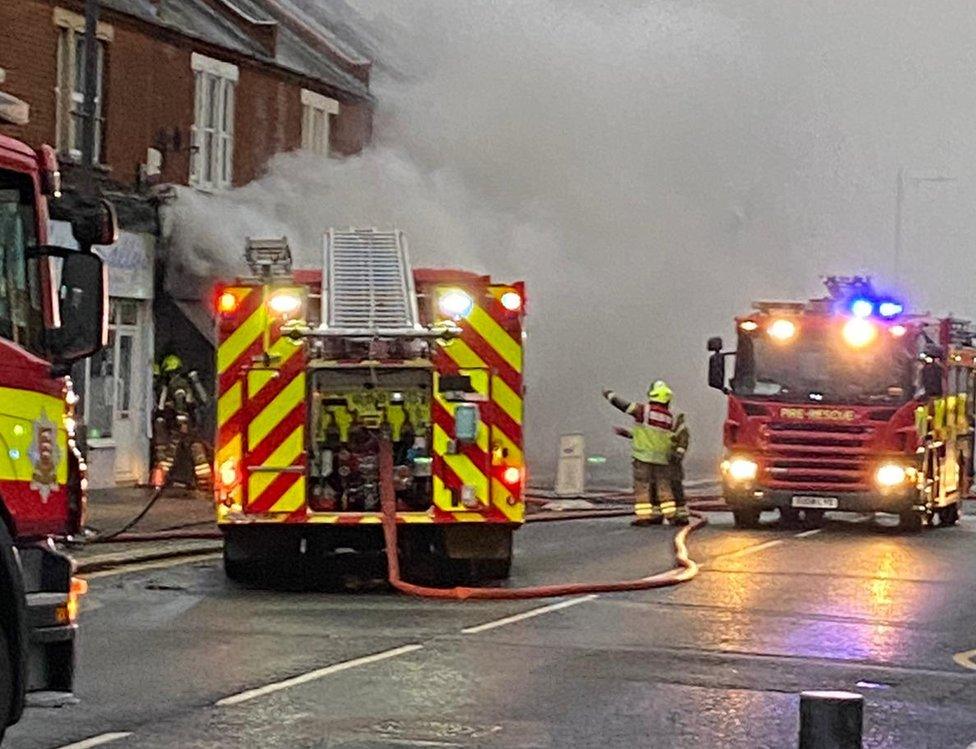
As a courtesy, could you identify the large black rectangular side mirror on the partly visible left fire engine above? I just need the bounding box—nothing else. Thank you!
[31,247,108,365]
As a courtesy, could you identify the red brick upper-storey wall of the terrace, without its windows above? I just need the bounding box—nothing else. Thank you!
[0,0,372,185]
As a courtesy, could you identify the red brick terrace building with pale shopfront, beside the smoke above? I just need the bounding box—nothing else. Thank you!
[0,0,373,485]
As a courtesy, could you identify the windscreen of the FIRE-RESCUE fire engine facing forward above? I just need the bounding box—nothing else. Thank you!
[732,324,915,404]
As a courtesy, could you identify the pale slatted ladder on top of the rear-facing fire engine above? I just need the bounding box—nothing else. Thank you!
[322,228,420,335]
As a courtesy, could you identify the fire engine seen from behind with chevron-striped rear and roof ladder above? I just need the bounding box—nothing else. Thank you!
[215,229,524,578]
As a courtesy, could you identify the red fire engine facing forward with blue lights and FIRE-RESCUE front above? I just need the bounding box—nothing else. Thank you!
[708,277,976,531]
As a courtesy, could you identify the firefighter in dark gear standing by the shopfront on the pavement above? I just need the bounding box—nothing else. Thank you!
[152,354,213,491]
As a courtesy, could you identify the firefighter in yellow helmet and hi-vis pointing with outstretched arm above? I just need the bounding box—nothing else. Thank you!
[603,380,688,525]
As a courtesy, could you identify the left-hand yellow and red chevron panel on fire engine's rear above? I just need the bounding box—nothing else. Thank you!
[216,286,306,515]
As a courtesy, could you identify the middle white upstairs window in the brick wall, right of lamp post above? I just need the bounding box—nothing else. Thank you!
[190,52,240,190]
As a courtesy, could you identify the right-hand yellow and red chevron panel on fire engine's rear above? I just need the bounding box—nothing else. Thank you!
[433,287,525,522]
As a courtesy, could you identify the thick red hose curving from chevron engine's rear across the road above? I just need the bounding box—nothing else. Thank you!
[379,440,707,601]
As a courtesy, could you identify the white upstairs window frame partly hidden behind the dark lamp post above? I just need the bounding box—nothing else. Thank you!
[53,8,115,163]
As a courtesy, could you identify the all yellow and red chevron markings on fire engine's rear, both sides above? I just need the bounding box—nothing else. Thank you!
[217,278,524,525]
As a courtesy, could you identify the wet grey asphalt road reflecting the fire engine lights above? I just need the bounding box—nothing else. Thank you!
[4,514,976,749]
